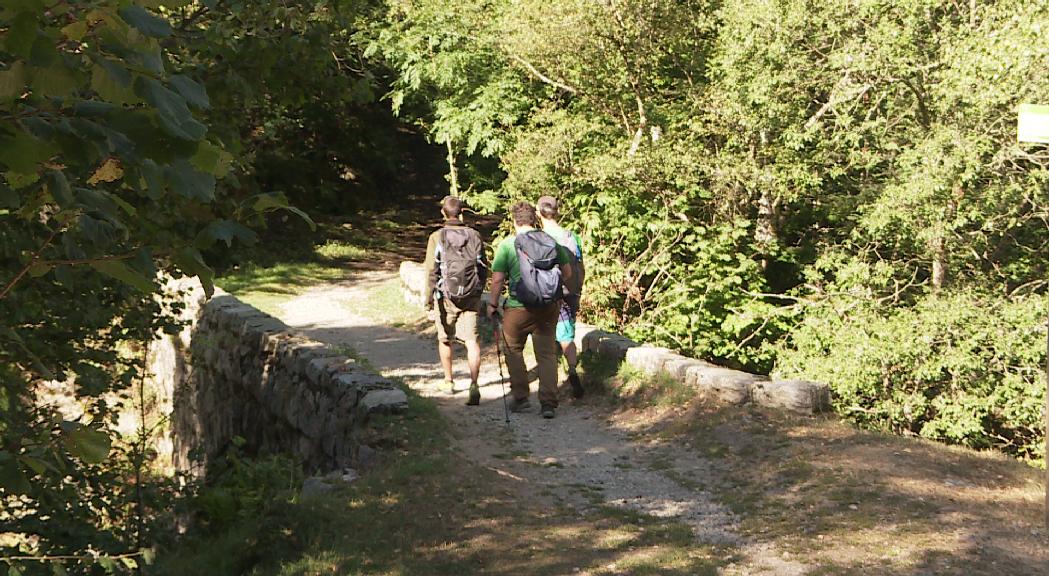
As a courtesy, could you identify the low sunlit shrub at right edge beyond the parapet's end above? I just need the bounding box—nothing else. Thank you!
[775,291,1047,462]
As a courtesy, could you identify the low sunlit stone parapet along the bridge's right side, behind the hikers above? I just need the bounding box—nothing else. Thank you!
[401,261,830,414]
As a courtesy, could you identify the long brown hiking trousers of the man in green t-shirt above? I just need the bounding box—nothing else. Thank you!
[502,302,560,408]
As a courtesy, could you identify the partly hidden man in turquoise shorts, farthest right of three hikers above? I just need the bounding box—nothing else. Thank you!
[535,196,586,398]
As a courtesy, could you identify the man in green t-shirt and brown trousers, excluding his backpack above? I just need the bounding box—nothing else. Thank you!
[488,202,572,419]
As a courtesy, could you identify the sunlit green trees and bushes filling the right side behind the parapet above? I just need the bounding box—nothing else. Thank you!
[379,0,1049,457]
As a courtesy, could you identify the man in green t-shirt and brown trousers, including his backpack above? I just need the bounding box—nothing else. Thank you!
[488,202,572,419]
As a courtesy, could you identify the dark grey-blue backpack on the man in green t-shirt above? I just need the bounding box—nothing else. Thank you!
[510,230,562,308]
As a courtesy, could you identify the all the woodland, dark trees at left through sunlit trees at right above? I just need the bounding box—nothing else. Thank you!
[0,0,1049,573]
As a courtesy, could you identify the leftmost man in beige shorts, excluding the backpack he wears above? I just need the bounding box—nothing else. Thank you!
[424,196,488,406]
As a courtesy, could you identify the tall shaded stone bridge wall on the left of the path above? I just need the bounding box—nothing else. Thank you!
[150,281,407,474]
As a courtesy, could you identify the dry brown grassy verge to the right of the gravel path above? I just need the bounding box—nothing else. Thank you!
[608,392,1049,576]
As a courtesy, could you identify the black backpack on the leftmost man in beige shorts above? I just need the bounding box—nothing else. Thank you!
[437,228,487,305]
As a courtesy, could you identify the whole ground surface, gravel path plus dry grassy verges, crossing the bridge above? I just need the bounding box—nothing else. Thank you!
[258,271,1049,575]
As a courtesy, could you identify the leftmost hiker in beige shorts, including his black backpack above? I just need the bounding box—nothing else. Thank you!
[423,196,488,406]
